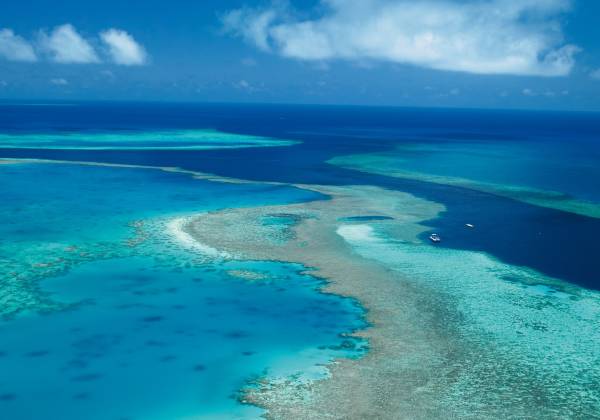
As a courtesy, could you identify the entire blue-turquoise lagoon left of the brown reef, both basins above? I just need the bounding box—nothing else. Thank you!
[0,163,363,420]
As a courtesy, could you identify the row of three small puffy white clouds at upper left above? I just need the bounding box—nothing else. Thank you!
[0,23,147,66]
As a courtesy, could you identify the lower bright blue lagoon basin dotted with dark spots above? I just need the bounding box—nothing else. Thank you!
[0,258,362,420]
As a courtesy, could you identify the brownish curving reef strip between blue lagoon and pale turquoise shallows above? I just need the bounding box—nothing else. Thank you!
[185,186,462,418]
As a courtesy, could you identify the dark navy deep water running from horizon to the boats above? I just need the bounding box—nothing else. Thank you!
[0,103,600,289]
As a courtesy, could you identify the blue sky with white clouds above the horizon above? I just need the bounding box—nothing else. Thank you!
[0,0,600,111]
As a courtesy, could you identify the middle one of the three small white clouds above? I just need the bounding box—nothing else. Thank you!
[40,24,100,64]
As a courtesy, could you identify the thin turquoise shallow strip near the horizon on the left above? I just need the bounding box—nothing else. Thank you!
[0,130,298,150]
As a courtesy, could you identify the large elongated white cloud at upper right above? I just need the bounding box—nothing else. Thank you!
[222,0,579,76]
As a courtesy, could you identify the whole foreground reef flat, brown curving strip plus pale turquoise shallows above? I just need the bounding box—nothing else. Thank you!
[183,185,600,419]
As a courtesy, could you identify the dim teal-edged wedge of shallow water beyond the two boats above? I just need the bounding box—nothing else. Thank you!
[330,139,600,218]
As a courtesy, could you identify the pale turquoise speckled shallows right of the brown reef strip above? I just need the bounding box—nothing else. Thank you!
[338,224,600,418]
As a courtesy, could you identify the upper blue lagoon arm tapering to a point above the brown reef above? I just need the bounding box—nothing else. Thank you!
[0,163,321,316]
